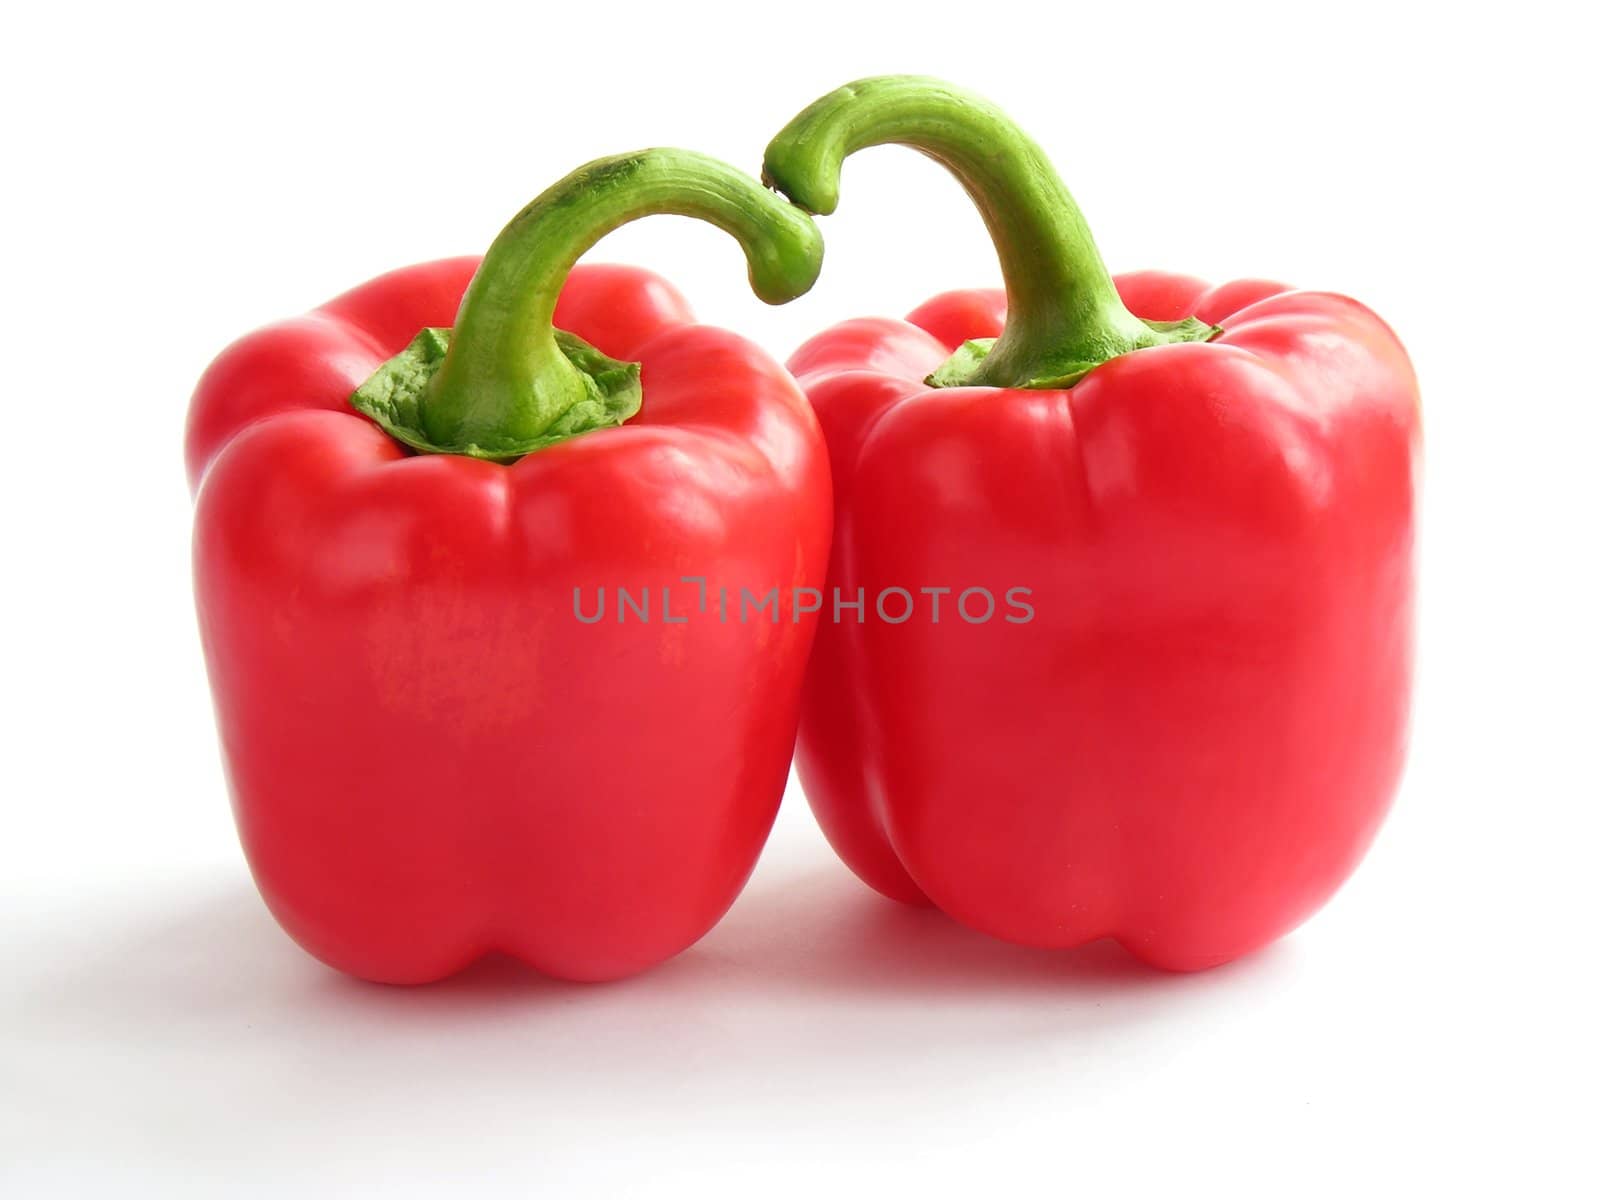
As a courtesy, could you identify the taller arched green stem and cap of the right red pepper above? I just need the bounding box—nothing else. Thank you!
[763,75,1221,387]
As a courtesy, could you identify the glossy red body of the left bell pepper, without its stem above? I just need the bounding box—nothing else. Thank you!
[187,259,832,984]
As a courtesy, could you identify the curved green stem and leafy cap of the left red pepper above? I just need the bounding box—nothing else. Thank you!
[350,149,822,462]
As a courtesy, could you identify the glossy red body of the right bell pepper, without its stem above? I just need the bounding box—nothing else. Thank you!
[789,272,1421,970]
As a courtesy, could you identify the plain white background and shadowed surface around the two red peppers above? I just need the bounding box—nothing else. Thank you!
[0,0,1600,1197]
